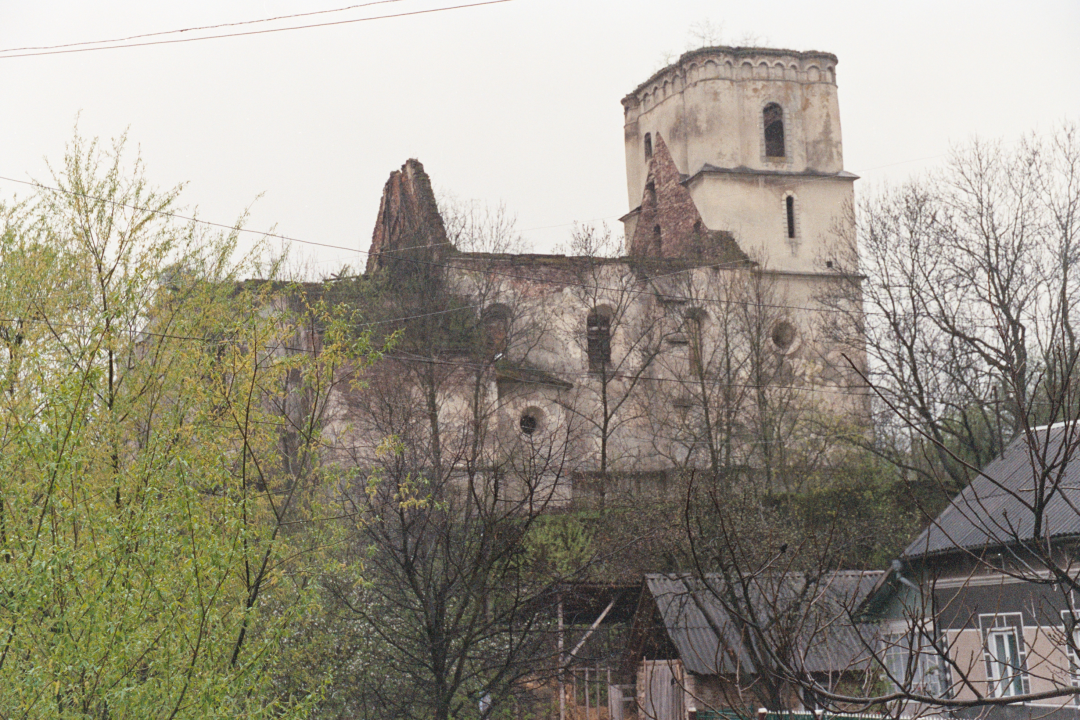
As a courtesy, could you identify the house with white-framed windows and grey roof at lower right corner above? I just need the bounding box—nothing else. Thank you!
[861,421,1080,720]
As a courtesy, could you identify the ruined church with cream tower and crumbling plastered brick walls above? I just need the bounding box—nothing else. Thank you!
[354,47,867,502]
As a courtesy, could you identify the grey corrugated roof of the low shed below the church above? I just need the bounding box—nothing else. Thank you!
[645,571,881,675]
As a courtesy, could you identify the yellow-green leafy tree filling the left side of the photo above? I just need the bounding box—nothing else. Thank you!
[0,132,368,718]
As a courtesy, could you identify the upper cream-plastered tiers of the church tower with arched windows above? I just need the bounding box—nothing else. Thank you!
[622,47,856,273]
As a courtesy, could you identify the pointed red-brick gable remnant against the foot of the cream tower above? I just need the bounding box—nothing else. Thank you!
[630,133,747,262]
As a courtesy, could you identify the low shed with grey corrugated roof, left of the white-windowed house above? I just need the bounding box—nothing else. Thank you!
[623,571,881,720]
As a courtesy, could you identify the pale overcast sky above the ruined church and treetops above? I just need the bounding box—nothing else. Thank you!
[0,0,1080,273]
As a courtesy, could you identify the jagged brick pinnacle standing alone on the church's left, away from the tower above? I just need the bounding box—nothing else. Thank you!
[367,159,453,273]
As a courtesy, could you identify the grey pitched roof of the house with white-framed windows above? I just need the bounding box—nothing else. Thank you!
[904,422,1080,558]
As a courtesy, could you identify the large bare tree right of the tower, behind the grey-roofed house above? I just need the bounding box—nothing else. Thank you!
[825,125,1080,492]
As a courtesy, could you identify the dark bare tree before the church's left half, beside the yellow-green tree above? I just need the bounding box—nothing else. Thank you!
[304,206,577,718]
